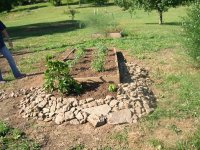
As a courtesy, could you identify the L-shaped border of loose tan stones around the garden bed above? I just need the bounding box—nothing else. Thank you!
[20,63,155,127]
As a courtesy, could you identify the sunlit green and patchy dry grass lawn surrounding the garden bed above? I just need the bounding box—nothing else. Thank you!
[0,3,200,150]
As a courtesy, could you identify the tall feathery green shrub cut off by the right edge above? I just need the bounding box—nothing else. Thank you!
[183,3,200,64]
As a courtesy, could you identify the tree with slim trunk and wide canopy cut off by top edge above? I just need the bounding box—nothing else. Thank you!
[115,0,195,24]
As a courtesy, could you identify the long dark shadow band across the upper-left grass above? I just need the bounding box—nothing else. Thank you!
[8,20,84,40]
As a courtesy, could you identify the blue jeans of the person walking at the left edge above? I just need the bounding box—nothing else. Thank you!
[0,46,21,81]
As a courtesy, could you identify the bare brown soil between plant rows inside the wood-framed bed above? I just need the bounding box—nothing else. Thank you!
[63,48,120,84]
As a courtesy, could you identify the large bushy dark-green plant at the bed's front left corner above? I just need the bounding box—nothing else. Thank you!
[44,59,82,94]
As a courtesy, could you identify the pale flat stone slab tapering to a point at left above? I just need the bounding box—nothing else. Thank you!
[82,104,111,116]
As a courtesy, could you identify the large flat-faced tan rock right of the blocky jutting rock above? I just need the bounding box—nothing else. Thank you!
[108,109,132,124]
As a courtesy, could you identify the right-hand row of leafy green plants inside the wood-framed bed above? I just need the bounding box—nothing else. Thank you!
[91,43,107,72]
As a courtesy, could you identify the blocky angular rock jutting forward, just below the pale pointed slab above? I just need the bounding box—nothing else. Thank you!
[87,114,106,127]
